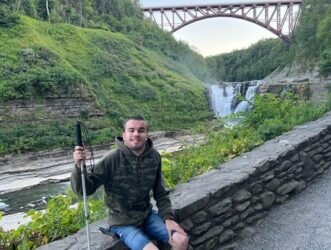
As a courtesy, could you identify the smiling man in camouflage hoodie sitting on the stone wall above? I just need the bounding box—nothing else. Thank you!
[71,116,188,250]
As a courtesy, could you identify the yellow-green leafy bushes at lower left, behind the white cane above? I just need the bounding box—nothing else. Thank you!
[0,188,106,249]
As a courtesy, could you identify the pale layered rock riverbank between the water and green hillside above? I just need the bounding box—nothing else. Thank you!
[0,132,202,195]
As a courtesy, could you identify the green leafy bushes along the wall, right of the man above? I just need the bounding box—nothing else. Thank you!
[162,93,330,188]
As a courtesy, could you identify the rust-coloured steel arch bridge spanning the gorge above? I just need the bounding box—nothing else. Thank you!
[142,0,302,43]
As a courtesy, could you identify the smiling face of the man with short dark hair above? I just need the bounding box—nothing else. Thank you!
[123,120,147,151]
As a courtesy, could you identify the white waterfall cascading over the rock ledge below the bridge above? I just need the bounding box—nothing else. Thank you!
[209,81,262,117]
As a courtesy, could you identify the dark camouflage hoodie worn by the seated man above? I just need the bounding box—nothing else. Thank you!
[71,137,173,226]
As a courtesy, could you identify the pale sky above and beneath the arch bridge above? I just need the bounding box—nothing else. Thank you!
[140,0,277,57]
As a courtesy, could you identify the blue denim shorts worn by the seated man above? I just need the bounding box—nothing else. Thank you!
[110,210,169,250]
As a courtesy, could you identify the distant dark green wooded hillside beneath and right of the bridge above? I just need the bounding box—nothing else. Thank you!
[206,0,331,81]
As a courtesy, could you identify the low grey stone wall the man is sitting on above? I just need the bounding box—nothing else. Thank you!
[40,113,331,250]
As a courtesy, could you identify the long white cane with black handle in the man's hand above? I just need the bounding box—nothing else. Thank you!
[76,122,91,250]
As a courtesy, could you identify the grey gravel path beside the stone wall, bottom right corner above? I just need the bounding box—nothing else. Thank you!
[236,167,331,250]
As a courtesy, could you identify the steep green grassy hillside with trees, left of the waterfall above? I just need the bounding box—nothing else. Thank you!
[0,0,211,154]
